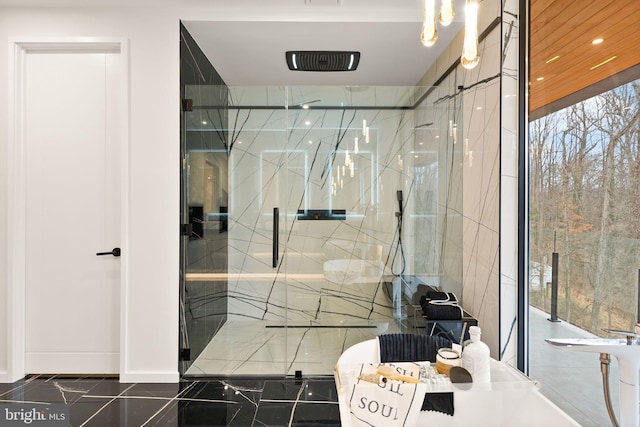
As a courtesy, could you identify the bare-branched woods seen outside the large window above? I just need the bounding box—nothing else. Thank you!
[529,80,640,336]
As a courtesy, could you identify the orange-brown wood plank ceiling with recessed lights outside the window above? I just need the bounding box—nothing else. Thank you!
[529,0,640,112]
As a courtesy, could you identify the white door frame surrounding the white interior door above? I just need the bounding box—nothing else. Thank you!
[6,37,130,382]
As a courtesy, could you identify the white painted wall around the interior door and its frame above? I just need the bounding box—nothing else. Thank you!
[0,8,179,382]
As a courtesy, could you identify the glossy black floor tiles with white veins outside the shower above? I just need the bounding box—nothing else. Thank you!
[0,377,340,427]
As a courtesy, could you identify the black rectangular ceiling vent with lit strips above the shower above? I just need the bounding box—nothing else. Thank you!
[286,51,360,71]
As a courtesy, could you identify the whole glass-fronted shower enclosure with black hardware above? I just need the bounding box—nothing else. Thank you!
[180,85,463,376]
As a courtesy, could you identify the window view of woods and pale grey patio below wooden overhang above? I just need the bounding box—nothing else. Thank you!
[529,80,640,426]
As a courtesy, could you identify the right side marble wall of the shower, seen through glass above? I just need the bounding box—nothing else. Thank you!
[406,93,466,298]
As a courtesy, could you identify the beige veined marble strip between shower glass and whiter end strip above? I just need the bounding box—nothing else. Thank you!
[462,27,501,358]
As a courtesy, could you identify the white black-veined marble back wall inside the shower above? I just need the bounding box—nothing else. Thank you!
[229,109,420,320]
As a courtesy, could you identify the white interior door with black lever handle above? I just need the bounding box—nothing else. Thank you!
[24,50,122,374]
